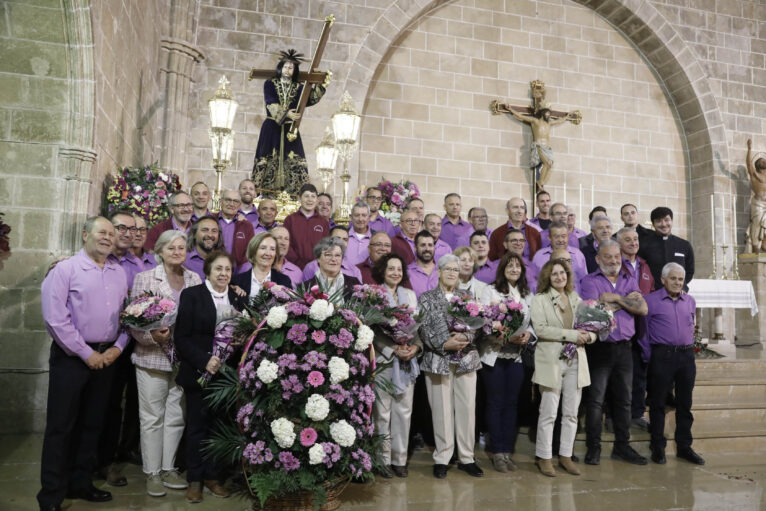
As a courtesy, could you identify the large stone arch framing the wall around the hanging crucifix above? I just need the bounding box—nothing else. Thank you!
[345,0,729,246]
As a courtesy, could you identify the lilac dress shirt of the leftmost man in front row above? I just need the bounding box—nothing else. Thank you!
[41,249,128,360]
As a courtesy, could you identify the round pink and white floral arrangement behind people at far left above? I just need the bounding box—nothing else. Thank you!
[104,163,181,226]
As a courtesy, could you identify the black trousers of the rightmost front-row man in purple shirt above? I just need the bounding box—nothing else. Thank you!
[648,344,697,449]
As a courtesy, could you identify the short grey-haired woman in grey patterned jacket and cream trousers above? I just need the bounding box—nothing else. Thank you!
[420,254,484,479]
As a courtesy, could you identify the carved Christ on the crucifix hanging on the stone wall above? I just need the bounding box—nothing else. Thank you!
[490,80,582,190]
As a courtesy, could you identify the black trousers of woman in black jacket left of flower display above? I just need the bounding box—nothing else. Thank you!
[184,387,218,483]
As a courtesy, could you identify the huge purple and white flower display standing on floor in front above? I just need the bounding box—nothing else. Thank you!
[210,286,380,510]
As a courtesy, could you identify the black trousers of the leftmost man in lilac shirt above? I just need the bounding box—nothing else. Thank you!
[37,342,114,506]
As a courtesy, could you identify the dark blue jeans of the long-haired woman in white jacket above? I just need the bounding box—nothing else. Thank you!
[479,358,524,453]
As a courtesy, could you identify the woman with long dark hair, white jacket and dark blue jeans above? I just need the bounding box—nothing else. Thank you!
[479,252,535,472]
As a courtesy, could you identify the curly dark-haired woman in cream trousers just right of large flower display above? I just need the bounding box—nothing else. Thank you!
[372,254,423,478]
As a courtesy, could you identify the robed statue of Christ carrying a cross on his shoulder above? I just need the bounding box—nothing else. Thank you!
[250,16,335,196]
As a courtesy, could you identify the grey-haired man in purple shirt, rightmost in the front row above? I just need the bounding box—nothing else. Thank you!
[641,263,705,465]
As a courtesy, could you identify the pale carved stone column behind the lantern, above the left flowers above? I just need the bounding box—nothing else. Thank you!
[160,0,205,176]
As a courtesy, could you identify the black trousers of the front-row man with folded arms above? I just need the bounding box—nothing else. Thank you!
[583,341,633,448]
